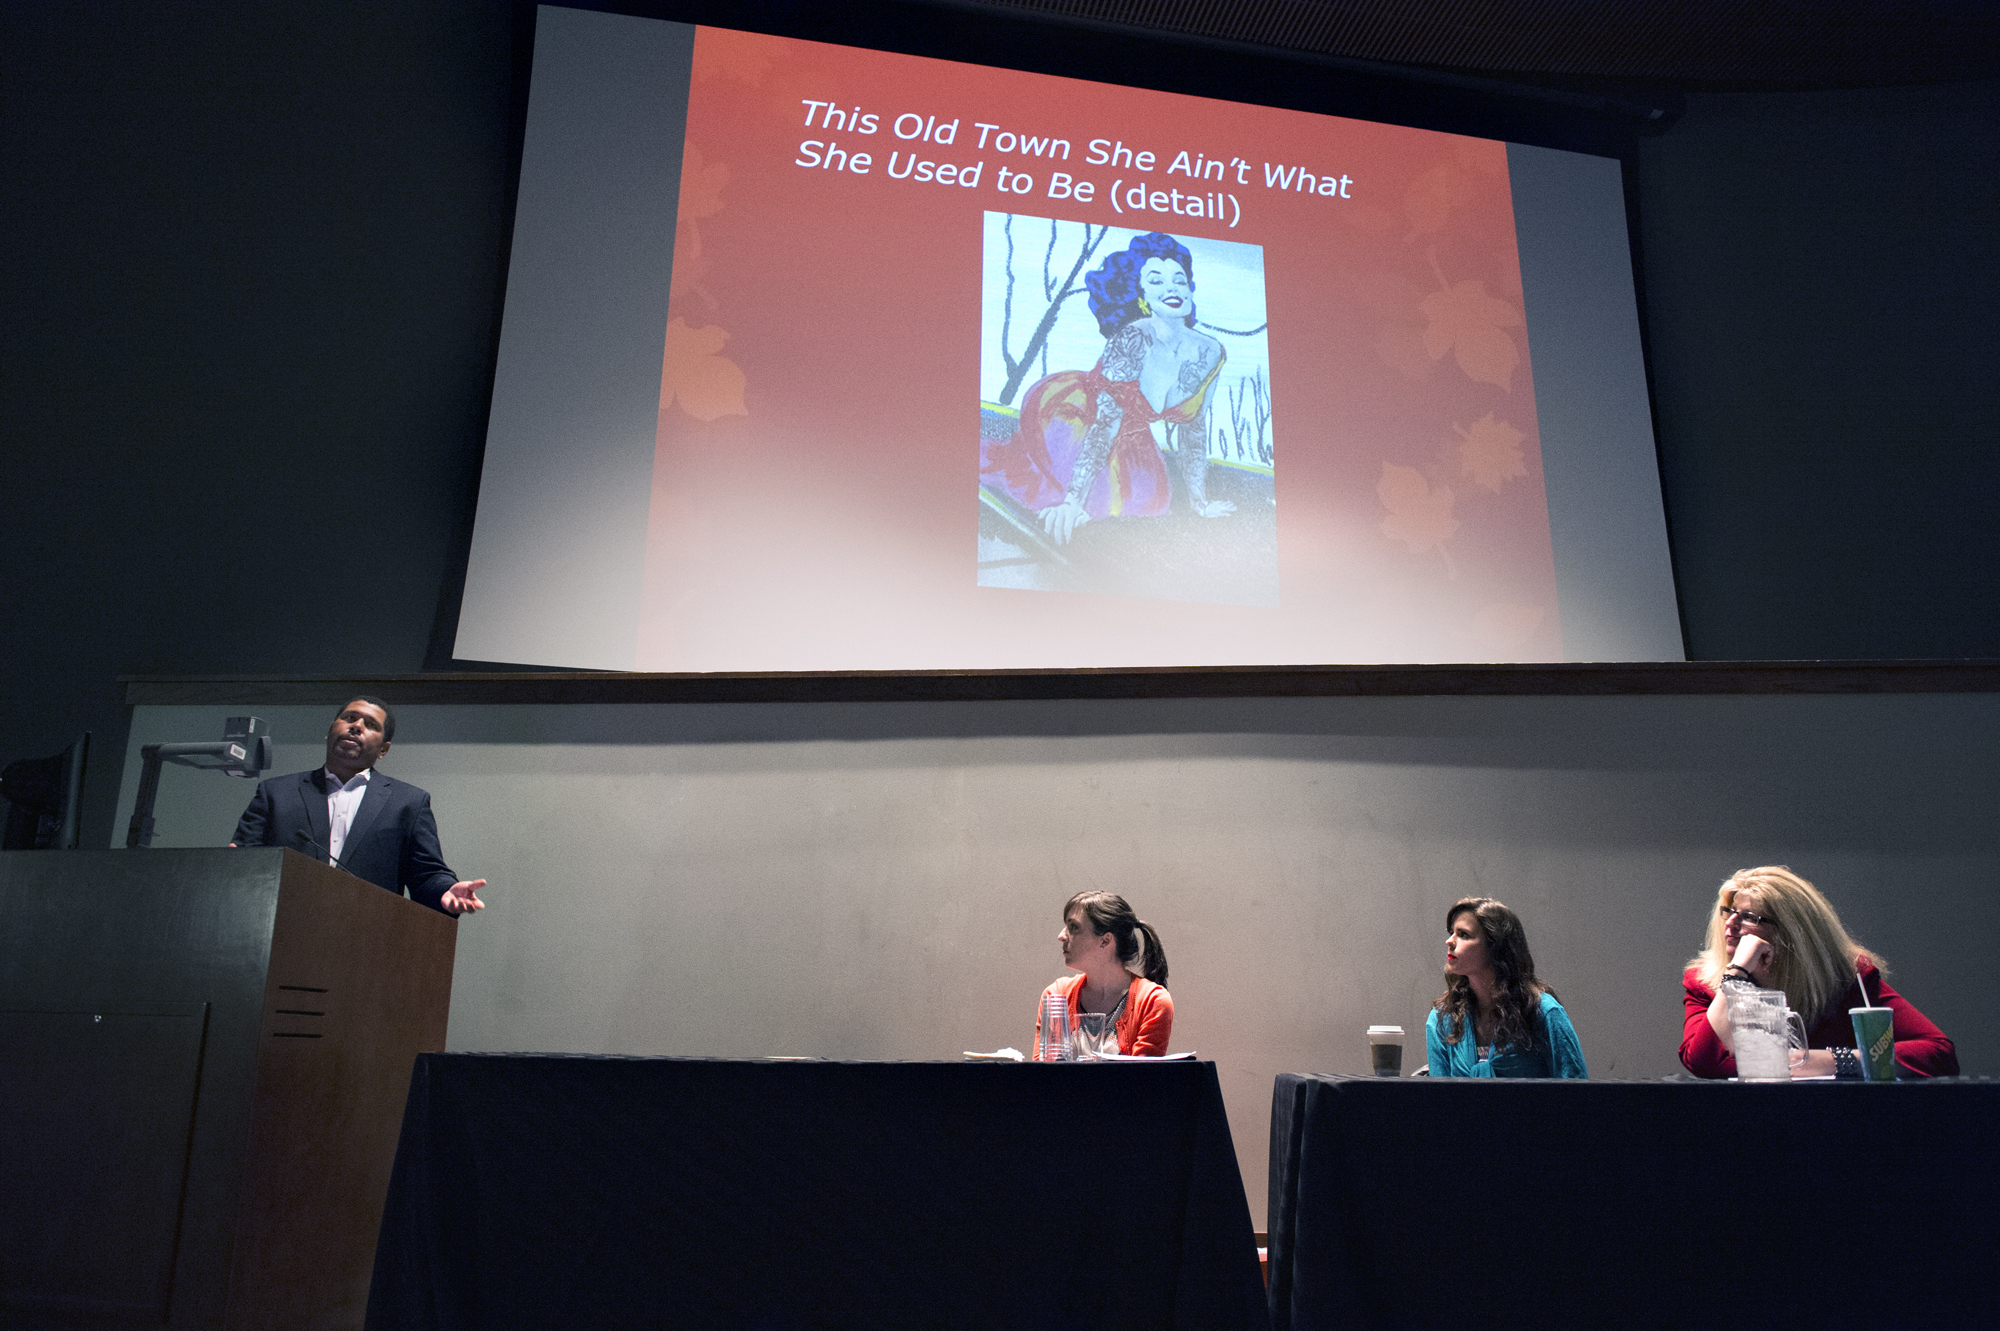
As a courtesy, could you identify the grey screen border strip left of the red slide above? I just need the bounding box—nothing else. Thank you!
[452,6,694,669]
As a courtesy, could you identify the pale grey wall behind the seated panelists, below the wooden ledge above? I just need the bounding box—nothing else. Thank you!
[116,695,2000,1225]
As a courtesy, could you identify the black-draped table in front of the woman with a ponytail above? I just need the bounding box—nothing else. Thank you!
[368,1053,1266,1331]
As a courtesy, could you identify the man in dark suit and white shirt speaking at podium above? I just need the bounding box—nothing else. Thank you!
[230,697,486,915]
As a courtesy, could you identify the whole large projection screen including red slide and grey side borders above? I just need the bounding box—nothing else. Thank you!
[454,6,1682,671]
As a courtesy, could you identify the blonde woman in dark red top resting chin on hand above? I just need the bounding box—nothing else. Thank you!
[1680,865,1958,1077]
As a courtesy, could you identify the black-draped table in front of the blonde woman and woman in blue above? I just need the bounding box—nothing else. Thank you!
[1270,1073,2000,1331]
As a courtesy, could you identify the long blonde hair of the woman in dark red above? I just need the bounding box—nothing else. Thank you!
[1688,863,1888,1027]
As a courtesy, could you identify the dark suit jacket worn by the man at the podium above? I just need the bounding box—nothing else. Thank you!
[234,769,458,909]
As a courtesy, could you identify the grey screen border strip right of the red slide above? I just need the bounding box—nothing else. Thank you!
[1506,144,1686,662]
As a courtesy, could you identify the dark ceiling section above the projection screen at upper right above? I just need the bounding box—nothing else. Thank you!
[968,0,2000,88]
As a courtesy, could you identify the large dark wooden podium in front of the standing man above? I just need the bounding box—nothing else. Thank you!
[0,849,458,1331]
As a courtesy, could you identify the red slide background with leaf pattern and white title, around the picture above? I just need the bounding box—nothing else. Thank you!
[636,28,1564,669]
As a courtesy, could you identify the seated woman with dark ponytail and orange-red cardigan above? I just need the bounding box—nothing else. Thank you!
[1034,891,1174,1057]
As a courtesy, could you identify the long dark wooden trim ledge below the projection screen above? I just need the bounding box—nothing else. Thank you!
[120,660,2000,707]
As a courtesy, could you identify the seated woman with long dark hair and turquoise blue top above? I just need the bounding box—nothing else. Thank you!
[1424,897,1590,1077]
